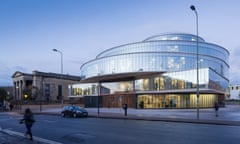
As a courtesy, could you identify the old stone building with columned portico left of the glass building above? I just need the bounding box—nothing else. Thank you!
[12,71,80,101]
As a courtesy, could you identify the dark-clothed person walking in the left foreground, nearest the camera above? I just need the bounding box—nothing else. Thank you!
[20,108,35,140]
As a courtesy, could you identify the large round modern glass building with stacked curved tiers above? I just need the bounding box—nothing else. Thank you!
[70,33,229,108]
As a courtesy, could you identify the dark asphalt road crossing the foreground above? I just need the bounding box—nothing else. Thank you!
[0,113,240,144]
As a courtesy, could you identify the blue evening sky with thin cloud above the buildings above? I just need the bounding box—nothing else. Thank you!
[0,0,240,86]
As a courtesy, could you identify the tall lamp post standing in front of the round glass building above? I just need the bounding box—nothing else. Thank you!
[190,5,199,119]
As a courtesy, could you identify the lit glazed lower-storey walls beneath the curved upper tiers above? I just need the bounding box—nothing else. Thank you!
[71,68,227,109]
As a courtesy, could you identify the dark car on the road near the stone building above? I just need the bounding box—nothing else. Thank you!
[61,105,88,117]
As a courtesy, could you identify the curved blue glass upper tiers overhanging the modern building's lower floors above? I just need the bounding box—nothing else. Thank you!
[81,34,229,78]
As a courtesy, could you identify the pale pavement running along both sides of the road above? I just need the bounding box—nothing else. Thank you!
[0,105,240,144]
